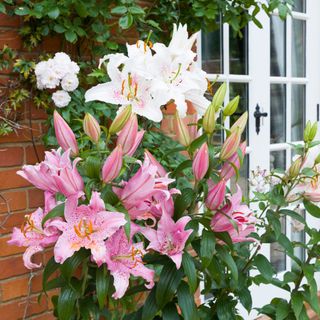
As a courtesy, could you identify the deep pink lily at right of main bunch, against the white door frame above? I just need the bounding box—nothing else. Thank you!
[211,186,256,243]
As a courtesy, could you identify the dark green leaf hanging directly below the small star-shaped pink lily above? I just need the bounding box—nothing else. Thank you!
[156,261,183,309]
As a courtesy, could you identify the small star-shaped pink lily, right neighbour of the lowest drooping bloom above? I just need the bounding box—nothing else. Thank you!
[141,212,192,269]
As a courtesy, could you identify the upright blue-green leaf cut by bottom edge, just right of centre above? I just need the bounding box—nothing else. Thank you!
[177,281,199,320]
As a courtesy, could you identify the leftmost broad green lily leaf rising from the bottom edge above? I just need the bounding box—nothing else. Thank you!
[57,287,78,320]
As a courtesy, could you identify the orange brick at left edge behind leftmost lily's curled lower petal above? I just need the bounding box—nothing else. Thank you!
[0,253,42,278]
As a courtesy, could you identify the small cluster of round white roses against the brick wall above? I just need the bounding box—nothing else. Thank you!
[35,52,80,108]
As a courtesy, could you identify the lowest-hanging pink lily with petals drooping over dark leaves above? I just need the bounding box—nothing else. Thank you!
[105,224,154,299]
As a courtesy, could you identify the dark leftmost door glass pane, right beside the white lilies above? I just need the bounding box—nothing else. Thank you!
[201,28,223,74]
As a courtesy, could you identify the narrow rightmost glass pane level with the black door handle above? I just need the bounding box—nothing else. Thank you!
[291,84,306,141]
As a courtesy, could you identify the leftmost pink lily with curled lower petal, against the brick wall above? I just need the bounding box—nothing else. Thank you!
[8,193,60,269]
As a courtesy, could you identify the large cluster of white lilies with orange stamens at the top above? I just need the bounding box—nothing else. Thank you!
[85,25,210,122]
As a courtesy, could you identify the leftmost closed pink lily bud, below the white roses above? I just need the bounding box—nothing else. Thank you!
[53,110,79,156]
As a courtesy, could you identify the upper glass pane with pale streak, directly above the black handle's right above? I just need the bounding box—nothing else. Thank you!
[270,16,286,77]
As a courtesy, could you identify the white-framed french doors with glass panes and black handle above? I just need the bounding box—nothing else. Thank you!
[198,0,320,319]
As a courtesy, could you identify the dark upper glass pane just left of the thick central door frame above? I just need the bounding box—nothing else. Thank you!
[229,28,248,74]
